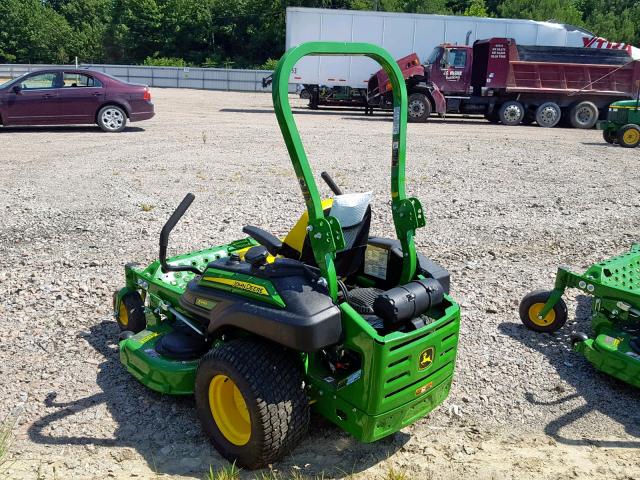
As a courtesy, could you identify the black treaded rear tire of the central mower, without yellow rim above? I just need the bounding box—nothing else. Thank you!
[198,338,309,469]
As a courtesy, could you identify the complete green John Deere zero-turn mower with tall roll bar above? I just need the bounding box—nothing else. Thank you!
[114,42,460,468]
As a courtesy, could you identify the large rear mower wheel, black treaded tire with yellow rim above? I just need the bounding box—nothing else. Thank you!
[195,339,309,469]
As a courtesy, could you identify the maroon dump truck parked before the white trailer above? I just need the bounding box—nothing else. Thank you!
[367,38,640,128]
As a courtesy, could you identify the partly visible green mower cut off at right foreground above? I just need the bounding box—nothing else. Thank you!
[520,244,640,387]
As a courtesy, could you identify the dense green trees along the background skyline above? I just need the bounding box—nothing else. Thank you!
[0,0,640,68]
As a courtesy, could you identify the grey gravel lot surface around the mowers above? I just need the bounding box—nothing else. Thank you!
[0,89,640,479]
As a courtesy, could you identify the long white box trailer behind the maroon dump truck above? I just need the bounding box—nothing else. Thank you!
[286,7,640,89]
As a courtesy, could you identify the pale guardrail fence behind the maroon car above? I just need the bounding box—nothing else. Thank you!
[0,64,296,93]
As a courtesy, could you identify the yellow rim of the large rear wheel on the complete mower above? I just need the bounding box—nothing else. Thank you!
[209,375,251,446]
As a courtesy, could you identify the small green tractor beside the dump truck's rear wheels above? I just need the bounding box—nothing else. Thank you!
[597,99,640,148]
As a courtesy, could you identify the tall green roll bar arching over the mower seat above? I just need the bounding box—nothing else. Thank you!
[273,42,425,300]
